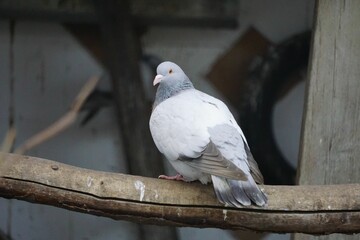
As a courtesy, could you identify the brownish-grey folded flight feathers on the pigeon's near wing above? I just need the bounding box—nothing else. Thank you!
[178,141,247,181]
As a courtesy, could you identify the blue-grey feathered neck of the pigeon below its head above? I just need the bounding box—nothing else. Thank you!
[153,79,194,108]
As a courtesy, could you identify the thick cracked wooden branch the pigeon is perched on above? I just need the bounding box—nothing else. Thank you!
[0,154,360,234]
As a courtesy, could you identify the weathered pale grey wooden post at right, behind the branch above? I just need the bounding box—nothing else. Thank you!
[295,0,360,240]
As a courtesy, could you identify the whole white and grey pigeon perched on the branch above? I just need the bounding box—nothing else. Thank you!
[149,62,267,207]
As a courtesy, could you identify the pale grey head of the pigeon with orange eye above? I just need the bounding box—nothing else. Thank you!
[153,61,189,86]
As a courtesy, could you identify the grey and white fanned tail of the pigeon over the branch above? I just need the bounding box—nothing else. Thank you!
[211,175,267,207]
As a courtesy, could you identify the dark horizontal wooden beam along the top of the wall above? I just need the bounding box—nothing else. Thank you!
[0,0,239,28]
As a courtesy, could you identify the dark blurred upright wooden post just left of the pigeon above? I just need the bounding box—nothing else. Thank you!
[94,0,177,240]
